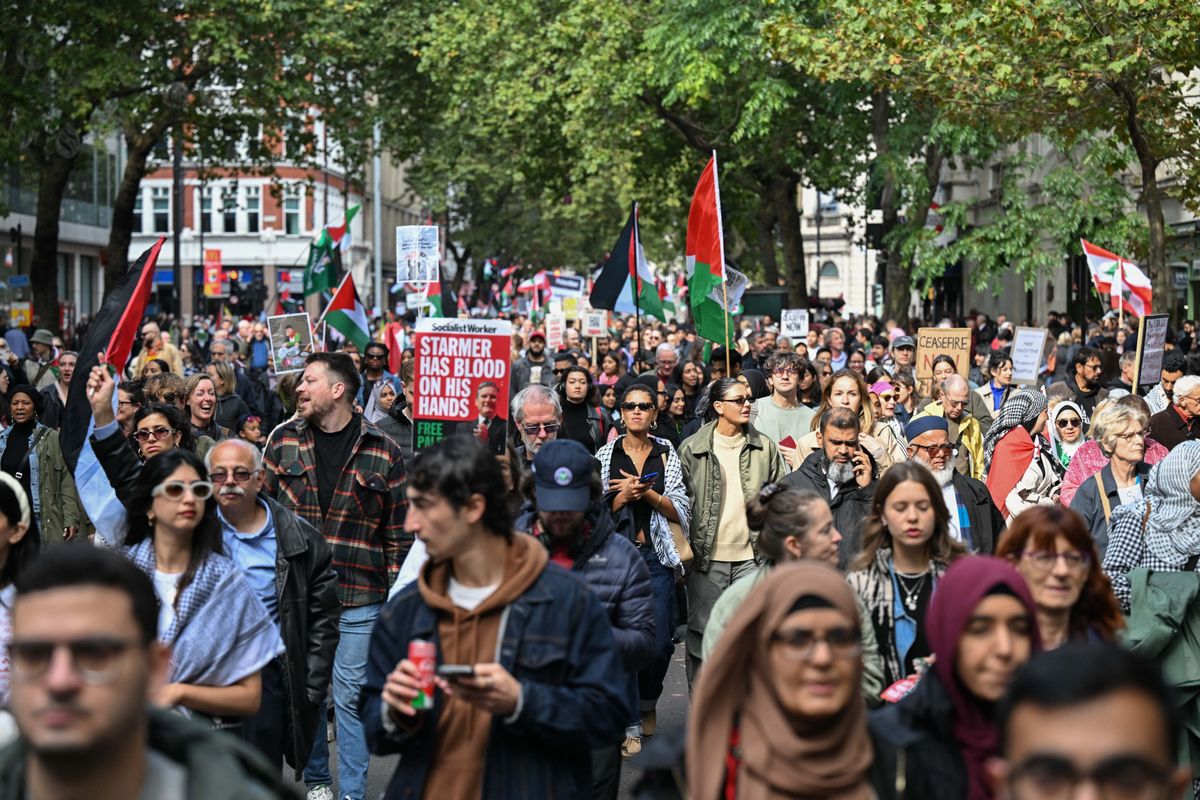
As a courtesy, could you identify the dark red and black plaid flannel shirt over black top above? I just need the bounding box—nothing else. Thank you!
[263,417,413,608]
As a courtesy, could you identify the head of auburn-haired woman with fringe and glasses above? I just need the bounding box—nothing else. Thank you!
[996,506,1124,650]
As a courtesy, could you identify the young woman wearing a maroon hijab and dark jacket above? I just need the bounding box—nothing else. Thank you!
[870,555,1042,800]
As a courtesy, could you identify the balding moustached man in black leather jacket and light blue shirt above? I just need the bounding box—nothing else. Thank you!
[204,439,341,776]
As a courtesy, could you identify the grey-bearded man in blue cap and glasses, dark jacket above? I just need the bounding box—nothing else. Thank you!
[905,416,1004,554]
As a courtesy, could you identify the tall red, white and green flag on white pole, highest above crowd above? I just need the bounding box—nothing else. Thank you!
[685,151,737,347]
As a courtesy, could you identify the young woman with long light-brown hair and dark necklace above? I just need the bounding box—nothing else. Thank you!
[846,461,967,686]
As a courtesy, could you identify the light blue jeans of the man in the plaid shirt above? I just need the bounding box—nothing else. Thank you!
[304,603,383,800]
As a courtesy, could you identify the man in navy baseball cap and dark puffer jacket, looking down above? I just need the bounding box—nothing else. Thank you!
[517,439,655,800]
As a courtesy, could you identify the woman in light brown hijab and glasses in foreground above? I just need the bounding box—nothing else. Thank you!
[688,561,876,800]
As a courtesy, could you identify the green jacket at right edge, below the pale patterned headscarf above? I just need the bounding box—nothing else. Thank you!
[1124,569,1200,775]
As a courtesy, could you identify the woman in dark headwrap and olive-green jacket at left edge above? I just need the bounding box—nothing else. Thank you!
[0,384,85,545]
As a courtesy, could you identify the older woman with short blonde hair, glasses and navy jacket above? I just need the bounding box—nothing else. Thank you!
[1070,403,1150,559]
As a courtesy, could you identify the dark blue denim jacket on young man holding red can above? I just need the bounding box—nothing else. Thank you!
[359,556,629,800]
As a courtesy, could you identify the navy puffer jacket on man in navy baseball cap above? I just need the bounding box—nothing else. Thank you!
[516,501,654,673]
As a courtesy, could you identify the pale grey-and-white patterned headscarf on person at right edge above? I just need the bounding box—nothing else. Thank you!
[1145,441,1200,564]
